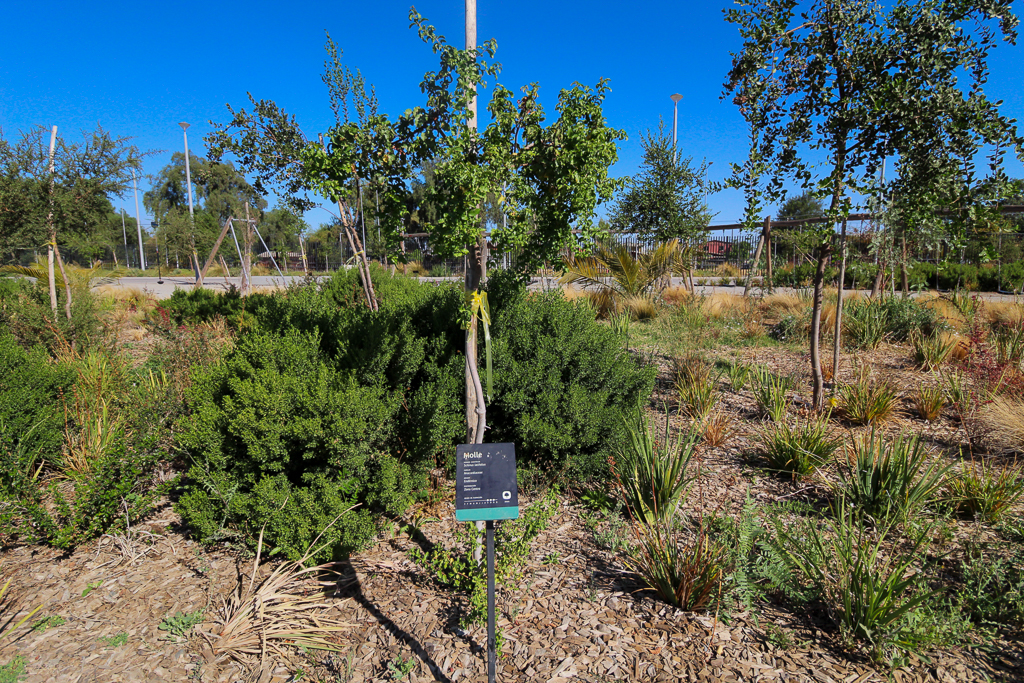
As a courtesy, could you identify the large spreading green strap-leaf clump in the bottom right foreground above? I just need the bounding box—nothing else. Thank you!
[775,498,932,659]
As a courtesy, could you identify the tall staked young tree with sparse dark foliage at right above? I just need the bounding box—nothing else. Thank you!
[726,0,1020,409]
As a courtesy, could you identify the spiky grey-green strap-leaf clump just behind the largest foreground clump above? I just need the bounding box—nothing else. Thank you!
[839,429,950,519]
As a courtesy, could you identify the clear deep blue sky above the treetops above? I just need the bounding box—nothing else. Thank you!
[0,0,1024,228]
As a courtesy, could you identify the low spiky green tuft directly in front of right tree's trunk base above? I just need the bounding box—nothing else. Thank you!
[758,416,843,476]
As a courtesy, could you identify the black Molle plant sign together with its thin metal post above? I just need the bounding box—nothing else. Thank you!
[455,443,519,683]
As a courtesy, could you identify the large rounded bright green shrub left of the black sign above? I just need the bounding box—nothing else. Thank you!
[177,330,417,559]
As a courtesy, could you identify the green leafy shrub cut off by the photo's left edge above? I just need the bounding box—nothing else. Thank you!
[0,333,74,475]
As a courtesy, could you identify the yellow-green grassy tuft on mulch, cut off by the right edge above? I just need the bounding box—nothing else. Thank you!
[945,460,1024,524]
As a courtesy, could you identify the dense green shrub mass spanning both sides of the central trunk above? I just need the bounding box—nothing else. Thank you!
[167,269,653,557]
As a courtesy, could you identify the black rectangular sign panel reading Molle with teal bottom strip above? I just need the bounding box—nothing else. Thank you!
[455,443,519,521]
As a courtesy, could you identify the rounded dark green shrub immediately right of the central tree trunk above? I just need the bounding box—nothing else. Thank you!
[487,291,655,479]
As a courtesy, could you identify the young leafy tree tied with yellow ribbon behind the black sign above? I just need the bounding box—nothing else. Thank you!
[303,9,625,443]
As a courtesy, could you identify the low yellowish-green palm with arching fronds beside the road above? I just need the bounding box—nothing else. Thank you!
[558,240,687,297]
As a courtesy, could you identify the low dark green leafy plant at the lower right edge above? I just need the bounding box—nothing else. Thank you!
[956,550,1024,627]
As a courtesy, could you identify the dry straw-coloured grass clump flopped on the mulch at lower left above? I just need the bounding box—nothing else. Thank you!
[197,508,353,666]
